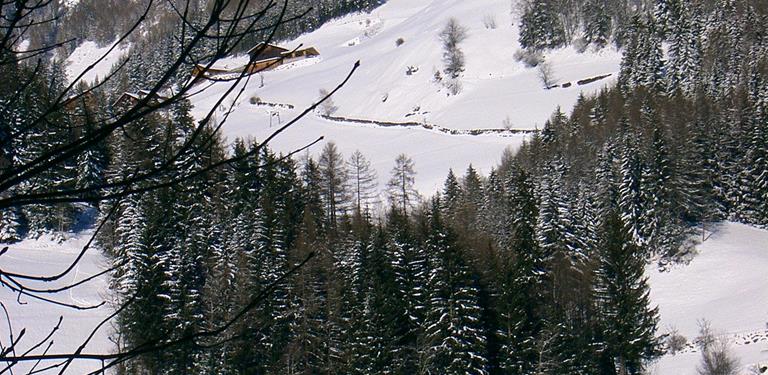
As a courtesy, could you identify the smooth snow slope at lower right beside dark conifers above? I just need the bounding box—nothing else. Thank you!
[647,222,768,375]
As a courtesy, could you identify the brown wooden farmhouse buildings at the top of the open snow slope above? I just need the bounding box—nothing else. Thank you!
[192,43,320,78]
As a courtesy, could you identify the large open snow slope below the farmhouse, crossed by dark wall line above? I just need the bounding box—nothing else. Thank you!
[193,0,620,194]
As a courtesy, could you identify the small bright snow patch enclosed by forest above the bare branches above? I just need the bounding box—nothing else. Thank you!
[66,41,130,83]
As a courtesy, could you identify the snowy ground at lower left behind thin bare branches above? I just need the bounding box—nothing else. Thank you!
[0,231,114,374]
